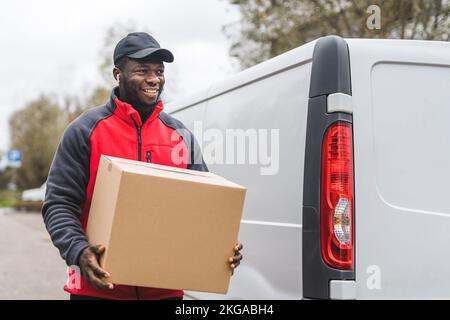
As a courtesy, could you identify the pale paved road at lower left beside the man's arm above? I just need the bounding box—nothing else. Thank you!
[0,209,68,300]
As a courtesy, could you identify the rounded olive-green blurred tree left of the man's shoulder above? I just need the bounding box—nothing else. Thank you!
[9,95,66,189]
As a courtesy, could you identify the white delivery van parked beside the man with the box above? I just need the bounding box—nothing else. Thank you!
[167,36,450,299]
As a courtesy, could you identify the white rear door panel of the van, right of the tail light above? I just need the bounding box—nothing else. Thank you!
[348,40,450,299]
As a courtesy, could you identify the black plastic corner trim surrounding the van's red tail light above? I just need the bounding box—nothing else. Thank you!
[302,36,355,299]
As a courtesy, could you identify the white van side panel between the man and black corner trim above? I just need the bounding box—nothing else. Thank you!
[173,45,313,299]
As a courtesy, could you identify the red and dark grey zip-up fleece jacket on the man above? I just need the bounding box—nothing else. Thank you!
[42,88,208,299]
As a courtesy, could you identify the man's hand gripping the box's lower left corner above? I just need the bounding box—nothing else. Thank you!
[80,245,114,290]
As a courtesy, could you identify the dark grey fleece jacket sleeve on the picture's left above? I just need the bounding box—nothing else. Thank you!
[42,121,90,266]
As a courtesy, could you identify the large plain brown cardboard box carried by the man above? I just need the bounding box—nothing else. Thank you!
[87,156,246,293]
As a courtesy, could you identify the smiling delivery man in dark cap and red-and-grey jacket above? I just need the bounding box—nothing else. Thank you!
[42,32,242,300]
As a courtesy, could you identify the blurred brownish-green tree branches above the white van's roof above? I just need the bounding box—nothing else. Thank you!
[229,0,450,68]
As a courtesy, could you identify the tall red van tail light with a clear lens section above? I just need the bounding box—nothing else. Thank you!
[320,121,354,270]
